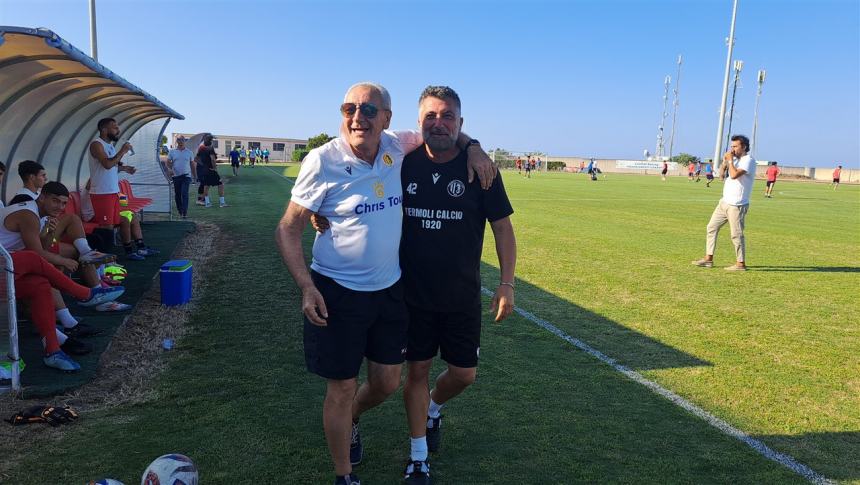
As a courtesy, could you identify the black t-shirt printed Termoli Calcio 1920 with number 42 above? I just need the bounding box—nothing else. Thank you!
[400,146,514,312]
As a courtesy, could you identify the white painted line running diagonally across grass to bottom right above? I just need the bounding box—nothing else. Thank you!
[481,287,835,485]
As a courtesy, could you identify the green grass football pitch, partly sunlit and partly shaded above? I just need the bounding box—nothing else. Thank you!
[0,166,860,484]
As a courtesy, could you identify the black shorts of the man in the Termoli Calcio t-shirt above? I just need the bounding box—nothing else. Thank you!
[406,304,481,368]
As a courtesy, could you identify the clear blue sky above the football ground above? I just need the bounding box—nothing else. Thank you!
[0,0,860,168]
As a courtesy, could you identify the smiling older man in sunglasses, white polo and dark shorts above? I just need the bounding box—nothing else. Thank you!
[276,83,494,484]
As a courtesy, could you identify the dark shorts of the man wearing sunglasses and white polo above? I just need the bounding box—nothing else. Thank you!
[304,271,409,379]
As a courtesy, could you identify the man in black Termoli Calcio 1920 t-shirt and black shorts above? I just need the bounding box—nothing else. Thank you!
[400,86,516,483]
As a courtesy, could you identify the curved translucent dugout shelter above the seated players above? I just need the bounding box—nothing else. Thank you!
[0,26,184,392]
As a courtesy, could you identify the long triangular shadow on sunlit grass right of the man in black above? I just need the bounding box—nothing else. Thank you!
[481,263,712,370]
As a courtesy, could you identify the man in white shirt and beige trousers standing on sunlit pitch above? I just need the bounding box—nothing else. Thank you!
[693,135,756,271]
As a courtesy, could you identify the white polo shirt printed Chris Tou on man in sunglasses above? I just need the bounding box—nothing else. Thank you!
[290,131,422,291]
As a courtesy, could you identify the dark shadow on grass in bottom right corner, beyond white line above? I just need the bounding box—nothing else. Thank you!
[755,431,860,480]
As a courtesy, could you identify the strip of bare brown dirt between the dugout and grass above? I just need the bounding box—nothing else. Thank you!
[0,223,232,476]
